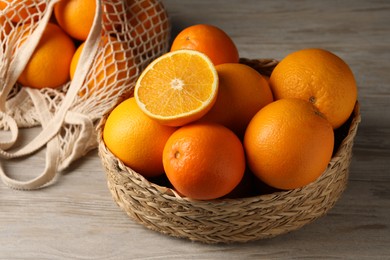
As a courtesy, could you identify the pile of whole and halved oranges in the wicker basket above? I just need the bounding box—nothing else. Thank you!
[103,24,357,200]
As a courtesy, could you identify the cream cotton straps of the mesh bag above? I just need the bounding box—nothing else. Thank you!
[0,0,102,190]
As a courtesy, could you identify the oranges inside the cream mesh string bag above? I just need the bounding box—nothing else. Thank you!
[0,0,169,91]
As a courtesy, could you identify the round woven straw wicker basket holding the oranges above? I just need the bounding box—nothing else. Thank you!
[98,59,360,243]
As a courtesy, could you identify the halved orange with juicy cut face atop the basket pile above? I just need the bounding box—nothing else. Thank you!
[134,50,218,126]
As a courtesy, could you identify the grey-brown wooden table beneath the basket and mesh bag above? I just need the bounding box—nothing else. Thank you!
[0,0,390,259]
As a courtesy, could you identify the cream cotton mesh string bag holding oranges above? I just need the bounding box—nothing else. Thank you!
[0,0,170,190]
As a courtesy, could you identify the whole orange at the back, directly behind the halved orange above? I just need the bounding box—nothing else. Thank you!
[171,24,239,65]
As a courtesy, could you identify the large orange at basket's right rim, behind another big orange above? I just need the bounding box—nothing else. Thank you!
[270,49,357,129]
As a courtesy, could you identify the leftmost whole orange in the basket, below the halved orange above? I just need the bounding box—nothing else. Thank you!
[103,97,175,177]
